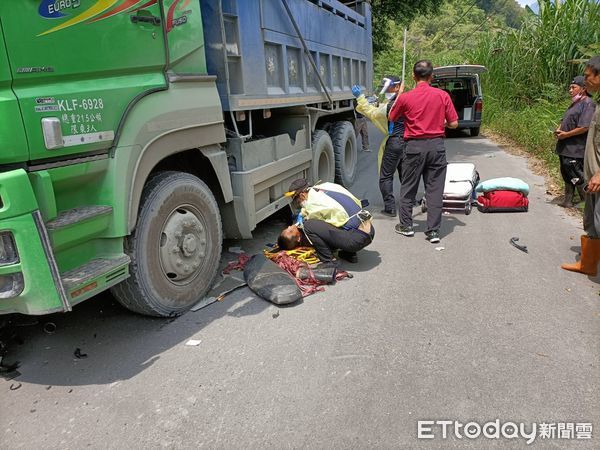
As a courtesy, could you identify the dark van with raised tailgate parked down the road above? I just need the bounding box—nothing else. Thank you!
[431,65,487,136]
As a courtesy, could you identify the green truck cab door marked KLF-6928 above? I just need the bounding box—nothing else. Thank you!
[0,0,166,161]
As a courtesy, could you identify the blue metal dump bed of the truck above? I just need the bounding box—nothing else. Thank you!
[200,0,373,111]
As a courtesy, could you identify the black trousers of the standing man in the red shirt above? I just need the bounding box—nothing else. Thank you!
[400,138,448,231]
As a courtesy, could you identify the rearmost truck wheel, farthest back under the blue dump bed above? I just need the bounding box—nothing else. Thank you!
[330,121,358,188]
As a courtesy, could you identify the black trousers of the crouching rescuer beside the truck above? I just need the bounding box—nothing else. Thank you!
[304,219,375,262]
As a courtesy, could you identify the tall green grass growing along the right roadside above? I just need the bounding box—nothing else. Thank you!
[467,0,600,179]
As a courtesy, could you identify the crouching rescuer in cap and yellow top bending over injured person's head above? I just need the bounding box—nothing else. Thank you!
[277,179,375,265]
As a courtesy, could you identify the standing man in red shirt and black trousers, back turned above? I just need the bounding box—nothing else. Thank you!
[389,61,458,244]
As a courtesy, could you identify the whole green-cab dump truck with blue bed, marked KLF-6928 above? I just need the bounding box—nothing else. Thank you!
[0,0,372,316]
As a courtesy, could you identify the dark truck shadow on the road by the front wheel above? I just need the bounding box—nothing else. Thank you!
[7,289,270,386]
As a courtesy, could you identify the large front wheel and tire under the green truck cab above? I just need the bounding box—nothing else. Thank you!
[112,171,223,317]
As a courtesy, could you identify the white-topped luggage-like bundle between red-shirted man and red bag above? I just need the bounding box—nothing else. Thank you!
[421,163,479,215]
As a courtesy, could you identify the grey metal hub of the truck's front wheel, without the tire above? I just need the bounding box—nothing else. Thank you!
[160,206,207,284]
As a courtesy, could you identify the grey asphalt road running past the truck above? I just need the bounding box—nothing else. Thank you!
[0,125,600,449]
